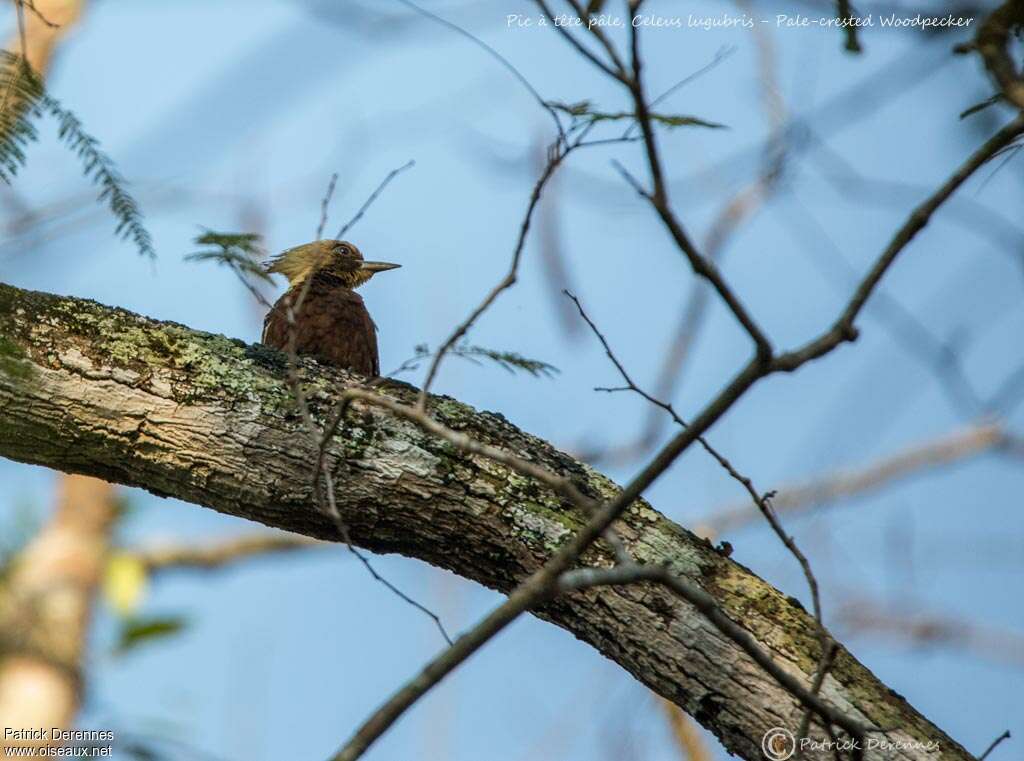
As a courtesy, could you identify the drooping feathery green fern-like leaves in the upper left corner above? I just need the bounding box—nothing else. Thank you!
[0,50,156,258]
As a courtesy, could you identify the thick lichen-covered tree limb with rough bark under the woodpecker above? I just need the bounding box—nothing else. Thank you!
[0,285,972,759]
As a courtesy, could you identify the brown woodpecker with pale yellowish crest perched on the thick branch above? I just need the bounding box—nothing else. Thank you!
[262,241,400,378]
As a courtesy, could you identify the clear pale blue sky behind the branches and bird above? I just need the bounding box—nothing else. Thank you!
[0,0,1024,761]
